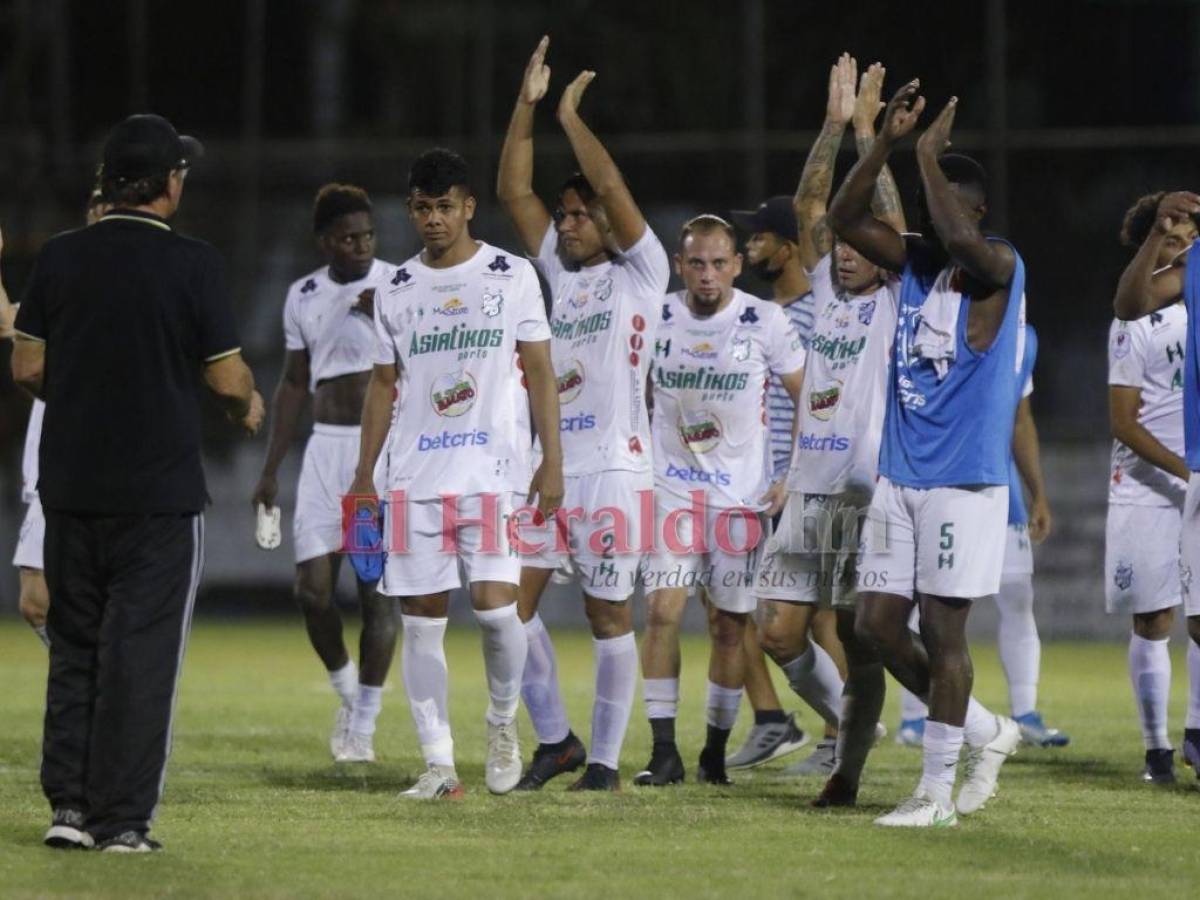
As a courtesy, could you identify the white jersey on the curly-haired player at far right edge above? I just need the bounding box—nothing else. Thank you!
[1109,302,1188,506]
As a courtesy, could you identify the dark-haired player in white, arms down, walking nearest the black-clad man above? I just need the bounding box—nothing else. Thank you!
[353,149,563,799]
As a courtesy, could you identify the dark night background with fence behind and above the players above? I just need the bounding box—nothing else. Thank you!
[0,0,1200,628]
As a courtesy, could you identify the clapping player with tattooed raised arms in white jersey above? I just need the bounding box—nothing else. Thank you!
[755,54,904,784]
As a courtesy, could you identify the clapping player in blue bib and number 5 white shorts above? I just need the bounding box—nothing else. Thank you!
[827,80,1025,827]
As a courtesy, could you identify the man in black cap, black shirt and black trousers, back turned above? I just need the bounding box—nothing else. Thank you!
[12,115,263,852]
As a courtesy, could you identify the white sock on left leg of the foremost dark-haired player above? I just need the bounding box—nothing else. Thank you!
[400,616,454,768]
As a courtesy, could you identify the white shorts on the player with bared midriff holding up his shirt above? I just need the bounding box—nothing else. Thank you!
[292,422,361,563]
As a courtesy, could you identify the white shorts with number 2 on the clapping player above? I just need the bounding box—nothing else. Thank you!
[520,469,654,602]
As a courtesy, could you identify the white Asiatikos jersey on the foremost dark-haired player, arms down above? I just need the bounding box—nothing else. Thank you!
[373,242,550,500]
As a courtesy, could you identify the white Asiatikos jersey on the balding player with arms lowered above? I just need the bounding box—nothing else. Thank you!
[652,290,805,510]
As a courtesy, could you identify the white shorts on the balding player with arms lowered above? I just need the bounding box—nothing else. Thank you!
[642,491,767,613]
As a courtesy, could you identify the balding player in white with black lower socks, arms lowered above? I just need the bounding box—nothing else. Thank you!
[634,215,805,785]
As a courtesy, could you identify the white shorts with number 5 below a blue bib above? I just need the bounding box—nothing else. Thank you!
[858,476,1008,600]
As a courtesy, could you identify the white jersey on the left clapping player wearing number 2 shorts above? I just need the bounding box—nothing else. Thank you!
[533,224,671,475]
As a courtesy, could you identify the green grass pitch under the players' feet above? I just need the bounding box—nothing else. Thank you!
[0,619,1200,900]
